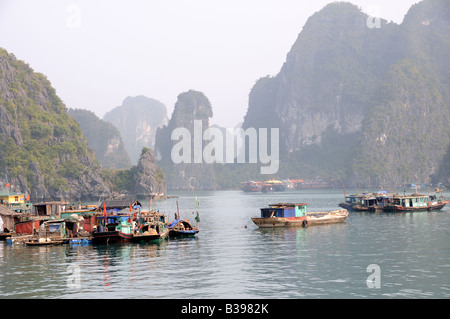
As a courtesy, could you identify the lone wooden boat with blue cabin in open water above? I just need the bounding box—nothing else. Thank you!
[252,203,349,228]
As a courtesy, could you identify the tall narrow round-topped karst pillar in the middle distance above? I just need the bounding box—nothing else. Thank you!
[155,90,217,190]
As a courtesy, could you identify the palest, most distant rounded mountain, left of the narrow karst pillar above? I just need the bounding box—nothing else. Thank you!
[103,95,168,165]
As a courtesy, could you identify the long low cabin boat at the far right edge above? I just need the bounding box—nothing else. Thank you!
[383,193,450,212]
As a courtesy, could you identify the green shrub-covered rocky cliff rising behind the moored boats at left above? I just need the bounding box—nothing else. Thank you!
[0,49,111,201]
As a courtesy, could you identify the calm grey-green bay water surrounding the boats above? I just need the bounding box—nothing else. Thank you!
[0,190,450,299]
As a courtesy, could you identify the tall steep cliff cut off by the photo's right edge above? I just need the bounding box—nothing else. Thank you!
[347,0,450,185]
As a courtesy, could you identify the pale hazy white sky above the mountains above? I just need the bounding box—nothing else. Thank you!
[0,0,419,127]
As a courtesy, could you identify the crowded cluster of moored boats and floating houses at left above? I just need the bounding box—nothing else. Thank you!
[0,191,200,246]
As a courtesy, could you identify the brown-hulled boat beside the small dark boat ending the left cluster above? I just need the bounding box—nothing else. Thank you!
[132,211,169,243]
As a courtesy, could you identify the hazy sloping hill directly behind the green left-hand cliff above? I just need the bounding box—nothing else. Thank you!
[69,109,131,169]
